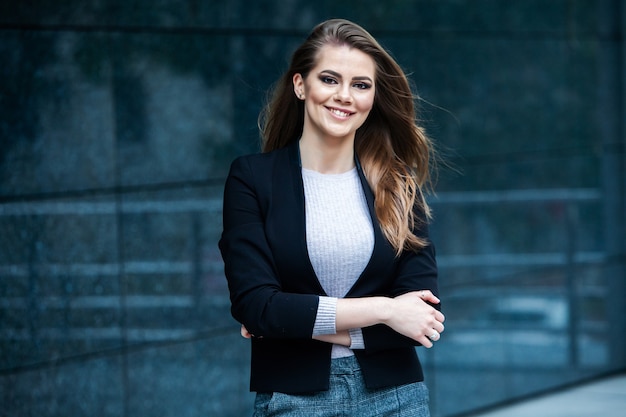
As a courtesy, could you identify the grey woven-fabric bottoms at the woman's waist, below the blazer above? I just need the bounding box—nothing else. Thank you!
[253,356,430,417]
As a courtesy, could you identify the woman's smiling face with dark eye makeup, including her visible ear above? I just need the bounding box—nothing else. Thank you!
[293,45,376,145]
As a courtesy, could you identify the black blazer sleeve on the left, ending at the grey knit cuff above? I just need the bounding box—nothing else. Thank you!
[218,157,319,339]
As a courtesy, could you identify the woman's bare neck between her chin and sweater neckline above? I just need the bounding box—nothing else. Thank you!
[299,138,354,174]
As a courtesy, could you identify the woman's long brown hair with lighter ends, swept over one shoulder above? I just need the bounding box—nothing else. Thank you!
[259,19,433,255]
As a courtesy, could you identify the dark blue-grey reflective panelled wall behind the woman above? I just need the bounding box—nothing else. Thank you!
[0,0,626,417]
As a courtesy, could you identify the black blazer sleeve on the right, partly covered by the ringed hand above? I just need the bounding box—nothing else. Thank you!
[363,197,441,352]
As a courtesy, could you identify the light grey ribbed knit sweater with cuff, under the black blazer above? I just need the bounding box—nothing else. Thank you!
[302,168,374,358]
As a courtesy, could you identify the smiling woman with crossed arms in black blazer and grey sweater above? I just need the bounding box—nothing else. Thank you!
[219,20,444,417]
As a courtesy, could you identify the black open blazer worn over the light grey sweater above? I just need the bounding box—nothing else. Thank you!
[219,141,438,393]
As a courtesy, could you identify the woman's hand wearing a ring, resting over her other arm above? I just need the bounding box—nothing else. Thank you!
[384,290,445,348]
